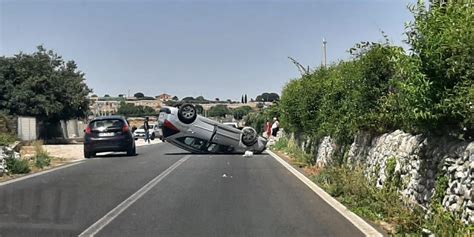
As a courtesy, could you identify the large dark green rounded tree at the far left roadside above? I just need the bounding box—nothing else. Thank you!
[0,46,91,122]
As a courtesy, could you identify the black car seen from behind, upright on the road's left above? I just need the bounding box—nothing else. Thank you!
[84,116,136,158]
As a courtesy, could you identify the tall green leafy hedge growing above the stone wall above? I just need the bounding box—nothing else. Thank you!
[279,2,474,141]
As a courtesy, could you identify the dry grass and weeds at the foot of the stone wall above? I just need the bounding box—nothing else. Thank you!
[272,138,474,236]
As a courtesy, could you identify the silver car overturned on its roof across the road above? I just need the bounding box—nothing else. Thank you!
[158,104,267,154]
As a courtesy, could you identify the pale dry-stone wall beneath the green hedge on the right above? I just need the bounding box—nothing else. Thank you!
[286,130,474,224]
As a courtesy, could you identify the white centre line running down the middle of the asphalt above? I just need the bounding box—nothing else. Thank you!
[79,155,190,237]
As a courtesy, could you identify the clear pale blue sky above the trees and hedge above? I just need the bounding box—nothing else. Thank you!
[0,0,413,100]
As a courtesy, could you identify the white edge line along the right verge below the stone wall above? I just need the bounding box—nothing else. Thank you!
[266,150,383,237]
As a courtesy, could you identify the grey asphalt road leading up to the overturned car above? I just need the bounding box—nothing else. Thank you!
[0,143,362,237]
